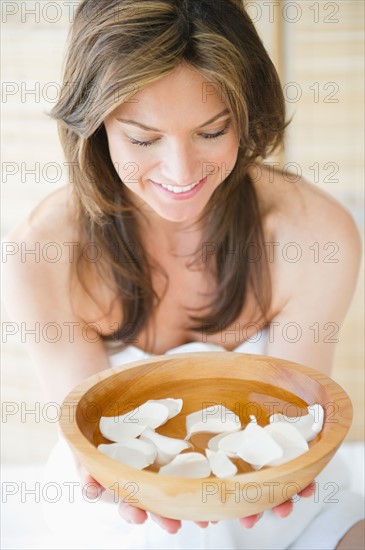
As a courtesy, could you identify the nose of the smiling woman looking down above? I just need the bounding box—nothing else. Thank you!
[161,142,203,187]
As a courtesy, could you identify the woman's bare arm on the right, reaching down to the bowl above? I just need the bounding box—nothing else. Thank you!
[267,182,362,375]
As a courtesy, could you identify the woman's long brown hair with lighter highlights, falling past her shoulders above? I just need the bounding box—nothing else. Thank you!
[51,0,287,352]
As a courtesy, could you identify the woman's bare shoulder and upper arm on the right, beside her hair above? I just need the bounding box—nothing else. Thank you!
[250,162,362,374]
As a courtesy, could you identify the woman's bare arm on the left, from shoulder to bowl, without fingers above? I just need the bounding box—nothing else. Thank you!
[3,215,109,404]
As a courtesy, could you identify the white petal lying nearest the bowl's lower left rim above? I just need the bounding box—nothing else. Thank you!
[98,439,157,470]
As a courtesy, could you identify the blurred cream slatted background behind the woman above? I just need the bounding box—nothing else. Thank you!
[1,0,364,548]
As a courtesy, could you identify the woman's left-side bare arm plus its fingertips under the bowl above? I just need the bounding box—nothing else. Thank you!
[3,219,213,532]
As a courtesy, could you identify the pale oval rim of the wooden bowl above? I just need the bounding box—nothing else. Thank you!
[59,351,353,490]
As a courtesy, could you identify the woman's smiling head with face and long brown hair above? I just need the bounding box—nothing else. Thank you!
[52,1,286,351]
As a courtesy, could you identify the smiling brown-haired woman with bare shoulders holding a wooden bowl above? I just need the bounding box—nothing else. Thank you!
[5,0,361,548]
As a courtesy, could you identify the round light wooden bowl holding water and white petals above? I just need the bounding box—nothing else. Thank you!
[60,352,352,521]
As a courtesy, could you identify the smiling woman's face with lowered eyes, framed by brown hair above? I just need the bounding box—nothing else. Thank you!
[104,65,239,226]
